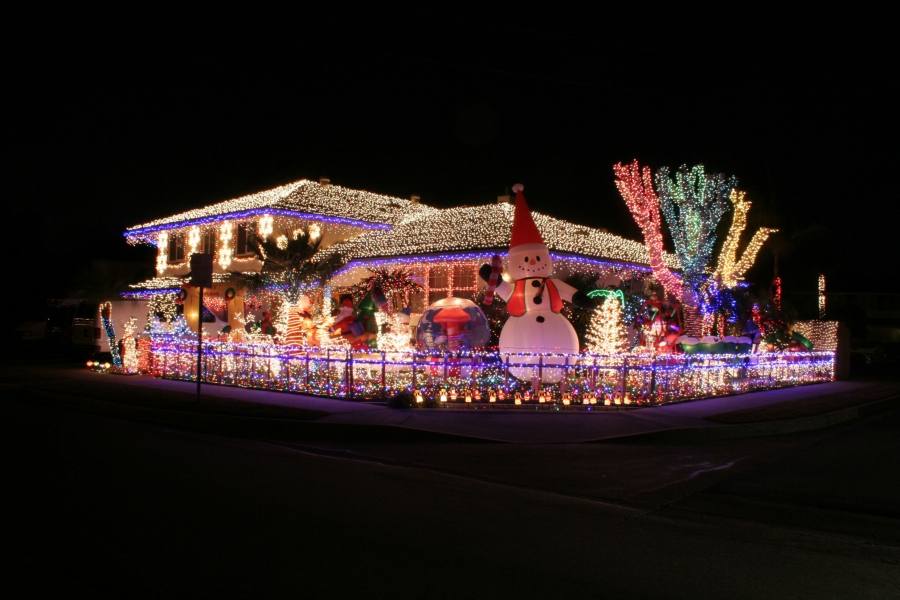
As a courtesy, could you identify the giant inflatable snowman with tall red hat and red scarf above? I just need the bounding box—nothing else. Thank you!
[480,184,581,383]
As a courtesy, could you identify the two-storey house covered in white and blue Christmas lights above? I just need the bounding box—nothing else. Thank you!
[123,179,677,333]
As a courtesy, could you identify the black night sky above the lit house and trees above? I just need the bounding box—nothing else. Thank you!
[5,19,900,322]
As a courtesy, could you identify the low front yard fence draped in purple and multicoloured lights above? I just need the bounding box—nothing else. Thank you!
[148,338,834,406]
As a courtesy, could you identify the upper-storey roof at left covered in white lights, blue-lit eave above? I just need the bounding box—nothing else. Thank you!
[125,179,425,243]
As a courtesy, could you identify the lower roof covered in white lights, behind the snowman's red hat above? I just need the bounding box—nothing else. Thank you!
[323,203,678,268]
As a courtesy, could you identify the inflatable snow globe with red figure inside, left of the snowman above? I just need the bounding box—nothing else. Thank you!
[416,297,491,351]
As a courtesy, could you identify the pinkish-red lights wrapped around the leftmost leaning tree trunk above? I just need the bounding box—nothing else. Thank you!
[613,159,682,298]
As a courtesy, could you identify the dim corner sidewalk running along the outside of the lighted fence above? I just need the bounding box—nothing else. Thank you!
[25,370,900,443]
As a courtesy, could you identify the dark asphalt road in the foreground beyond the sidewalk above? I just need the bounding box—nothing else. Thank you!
[3,368,900,599]
